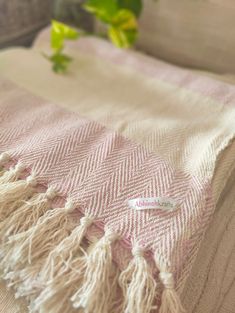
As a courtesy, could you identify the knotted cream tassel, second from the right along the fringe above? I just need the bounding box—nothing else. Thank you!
[119,246,156,313]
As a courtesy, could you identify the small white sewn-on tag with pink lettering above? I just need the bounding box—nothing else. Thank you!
[128,197,177,211]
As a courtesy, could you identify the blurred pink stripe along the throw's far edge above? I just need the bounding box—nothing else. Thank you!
[69,38,235,105]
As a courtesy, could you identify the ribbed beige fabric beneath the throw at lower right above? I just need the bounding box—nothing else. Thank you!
[181,168,235,313]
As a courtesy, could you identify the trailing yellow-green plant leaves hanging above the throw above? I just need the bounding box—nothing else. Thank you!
[46,0,142,73]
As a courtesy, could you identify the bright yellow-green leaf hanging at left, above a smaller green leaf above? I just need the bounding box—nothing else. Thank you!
[51,20,79,50]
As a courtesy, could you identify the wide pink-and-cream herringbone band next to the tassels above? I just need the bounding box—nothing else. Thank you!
[0,78,218,290]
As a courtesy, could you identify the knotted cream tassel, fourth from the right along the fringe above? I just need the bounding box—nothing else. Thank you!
[40,215,94,283]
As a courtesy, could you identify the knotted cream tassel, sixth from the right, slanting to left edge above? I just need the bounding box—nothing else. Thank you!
[0,187,56,241]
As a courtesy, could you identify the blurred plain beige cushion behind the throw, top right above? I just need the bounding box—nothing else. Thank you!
[138,0,235,73]
